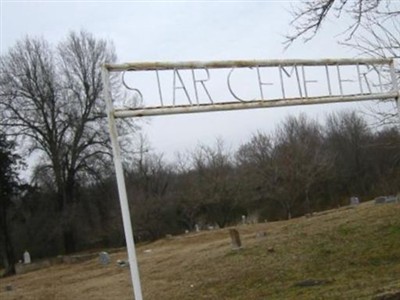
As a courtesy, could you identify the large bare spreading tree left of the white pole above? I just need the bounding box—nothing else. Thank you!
[0,31,120,252]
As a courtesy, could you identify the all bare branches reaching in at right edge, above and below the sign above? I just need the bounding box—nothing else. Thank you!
[284,0,400,129]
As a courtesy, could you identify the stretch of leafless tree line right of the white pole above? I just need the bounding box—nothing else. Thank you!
[122,112,400,239]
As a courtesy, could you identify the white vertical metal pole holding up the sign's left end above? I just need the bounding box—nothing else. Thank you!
[102,66,143,300]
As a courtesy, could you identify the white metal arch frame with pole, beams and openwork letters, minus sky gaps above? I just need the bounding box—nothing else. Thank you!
[102,58,400,300]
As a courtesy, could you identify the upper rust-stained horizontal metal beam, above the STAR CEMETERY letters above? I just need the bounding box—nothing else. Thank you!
[104,58,393,72]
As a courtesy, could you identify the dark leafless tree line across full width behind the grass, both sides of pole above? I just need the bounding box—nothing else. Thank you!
[2,112,400,274]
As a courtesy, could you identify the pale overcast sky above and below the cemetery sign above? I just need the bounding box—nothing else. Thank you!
[1,0,376,164]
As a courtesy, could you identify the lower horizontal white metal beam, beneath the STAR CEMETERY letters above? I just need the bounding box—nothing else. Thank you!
[114,92,398,118]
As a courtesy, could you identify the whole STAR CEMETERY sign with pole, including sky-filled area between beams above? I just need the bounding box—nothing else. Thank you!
[102,59,400,300]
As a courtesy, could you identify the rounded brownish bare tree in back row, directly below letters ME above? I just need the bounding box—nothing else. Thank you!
[271,115,331,219]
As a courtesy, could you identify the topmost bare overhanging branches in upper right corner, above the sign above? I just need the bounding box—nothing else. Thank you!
[285,0,400,46]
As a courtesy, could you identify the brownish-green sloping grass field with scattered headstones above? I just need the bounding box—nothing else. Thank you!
[0,202,400,300]
